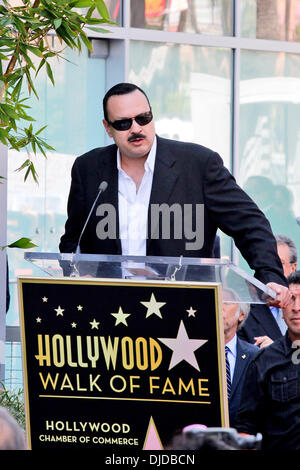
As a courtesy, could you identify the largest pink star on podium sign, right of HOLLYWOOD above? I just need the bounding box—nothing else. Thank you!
[158,320,207,372]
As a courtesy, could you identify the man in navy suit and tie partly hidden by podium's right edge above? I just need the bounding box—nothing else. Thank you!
[223,289,259,427]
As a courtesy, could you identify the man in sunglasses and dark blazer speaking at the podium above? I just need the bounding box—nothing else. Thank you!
[59,83,290,305]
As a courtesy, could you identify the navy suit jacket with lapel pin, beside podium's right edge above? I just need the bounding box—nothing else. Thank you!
[229,338,260,427]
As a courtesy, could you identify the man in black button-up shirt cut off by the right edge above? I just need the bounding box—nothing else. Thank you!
[235,271,300,450]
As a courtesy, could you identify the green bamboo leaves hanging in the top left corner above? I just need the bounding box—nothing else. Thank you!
[0,0,114,181]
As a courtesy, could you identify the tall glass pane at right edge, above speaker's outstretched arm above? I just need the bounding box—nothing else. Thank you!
[239,51,300,269]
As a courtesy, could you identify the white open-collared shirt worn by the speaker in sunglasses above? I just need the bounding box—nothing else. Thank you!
[117,137,157,256]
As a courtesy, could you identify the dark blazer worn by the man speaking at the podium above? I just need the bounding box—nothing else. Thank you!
[59,137,287,285]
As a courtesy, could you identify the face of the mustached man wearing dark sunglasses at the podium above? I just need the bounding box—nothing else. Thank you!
[103,90,155,158]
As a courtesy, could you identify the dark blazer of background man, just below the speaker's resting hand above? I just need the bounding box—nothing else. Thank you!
[237,304,282,343]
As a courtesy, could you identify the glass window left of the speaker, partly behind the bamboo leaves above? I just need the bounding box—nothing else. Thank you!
[7,39,105,325]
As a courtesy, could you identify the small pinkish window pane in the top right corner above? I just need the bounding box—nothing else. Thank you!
[241,0,300,41]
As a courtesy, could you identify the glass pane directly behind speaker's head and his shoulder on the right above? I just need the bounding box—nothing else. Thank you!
[129,41,232,256]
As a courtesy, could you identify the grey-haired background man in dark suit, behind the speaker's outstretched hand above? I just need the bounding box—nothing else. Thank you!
[238,234,298,347]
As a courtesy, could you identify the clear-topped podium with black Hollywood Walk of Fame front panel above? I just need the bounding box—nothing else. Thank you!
[18,252,275,452]
